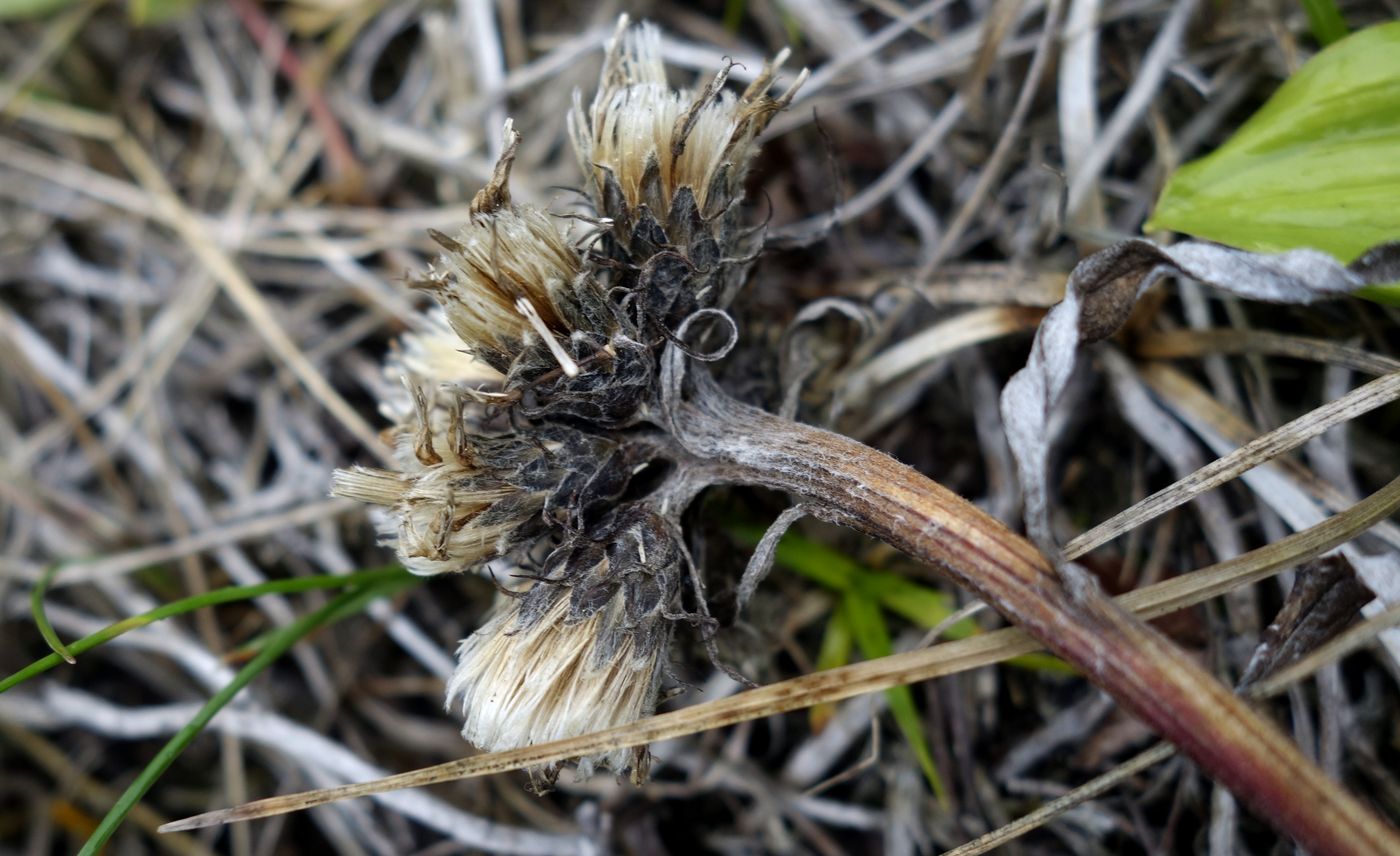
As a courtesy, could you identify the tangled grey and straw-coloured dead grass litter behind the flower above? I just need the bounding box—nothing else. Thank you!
[0,0,1400,853]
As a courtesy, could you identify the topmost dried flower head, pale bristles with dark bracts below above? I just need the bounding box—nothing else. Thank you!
[570,15,806,337]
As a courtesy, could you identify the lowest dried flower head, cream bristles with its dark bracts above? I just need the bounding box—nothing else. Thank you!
[448,510,679,779]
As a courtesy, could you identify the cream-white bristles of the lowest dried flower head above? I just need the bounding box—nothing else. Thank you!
[447,597,668,776]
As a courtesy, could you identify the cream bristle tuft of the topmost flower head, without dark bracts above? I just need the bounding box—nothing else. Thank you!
[570,15,806,221]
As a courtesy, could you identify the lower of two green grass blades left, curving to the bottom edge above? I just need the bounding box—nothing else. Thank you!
[78,579,409,856]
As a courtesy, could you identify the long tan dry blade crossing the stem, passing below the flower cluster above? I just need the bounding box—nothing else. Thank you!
[162,479,1400,832]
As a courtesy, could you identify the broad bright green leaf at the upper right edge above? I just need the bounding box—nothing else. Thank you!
[1144,21,1400,266]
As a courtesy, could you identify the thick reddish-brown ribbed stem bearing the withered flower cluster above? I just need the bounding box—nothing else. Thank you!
[675,386,1400,856]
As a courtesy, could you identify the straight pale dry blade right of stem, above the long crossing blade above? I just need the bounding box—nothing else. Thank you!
[1064,373,1400,559]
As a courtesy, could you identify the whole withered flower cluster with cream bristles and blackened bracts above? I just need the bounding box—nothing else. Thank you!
[333,18,805,778]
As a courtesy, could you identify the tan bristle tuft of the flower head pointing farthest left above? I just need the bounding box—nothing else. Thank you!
[330,460,545,574]
